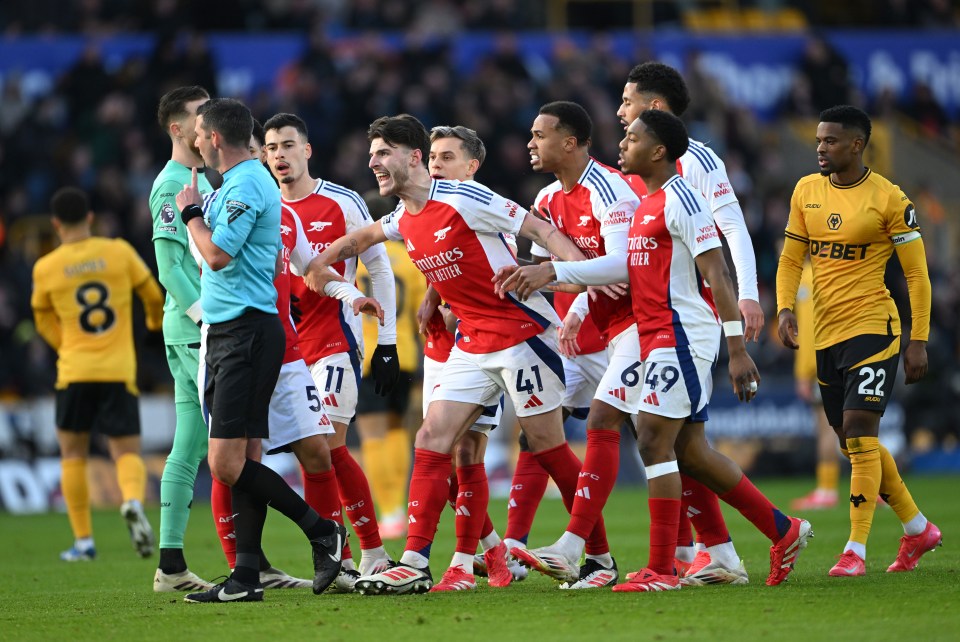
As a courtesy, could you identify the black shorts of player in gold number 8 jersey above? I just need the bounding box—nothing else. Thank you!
[56,381,140,437]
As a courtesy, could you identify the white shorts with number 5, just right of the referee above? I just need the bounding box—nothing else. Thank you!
[263,359,333,455]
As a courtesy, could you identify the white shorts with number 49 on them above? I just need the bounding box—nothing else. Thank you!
[640,348,713,422]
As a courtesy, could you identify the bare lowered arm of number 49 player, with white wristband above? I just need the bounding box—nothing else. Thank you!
[696,247,760,403]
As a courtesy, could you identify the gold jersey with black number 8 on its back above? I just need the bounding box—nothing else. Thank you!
[30,237,163,393]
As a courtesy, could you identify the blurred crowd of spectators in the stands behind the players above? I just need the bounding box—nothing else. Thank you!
[0,0,960,450]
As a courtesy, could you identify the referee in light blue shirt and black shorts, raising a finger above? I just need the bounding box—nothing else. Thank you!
[177,98,346,603]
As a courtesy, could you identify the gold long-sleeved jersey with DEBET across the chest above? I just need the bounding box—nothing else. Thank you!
[777,169,929,350]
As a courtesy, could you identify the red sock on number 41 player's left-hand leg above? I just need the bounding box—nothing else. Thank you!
[404,448,452,557]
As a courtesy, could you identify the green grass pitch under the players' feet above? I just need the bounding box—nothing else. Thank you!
[0,477,960,642]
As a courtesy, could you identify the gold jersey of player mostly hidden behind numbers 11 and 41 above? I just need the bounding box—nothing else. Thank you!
[357,241,427,375]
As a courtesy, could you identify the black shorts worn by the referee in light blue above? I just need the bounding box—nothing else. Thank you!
[200,311,286,439]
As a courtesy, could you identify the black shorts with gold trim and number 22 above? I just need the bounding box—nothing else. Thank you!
[817,334,900,428]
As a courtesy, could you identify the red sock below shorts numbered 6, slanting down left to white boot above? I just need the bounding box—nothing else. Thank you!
[567,430,620,540]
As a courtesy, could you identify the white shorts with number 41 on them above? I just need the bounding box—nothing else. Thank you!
[433,325,565,417]
